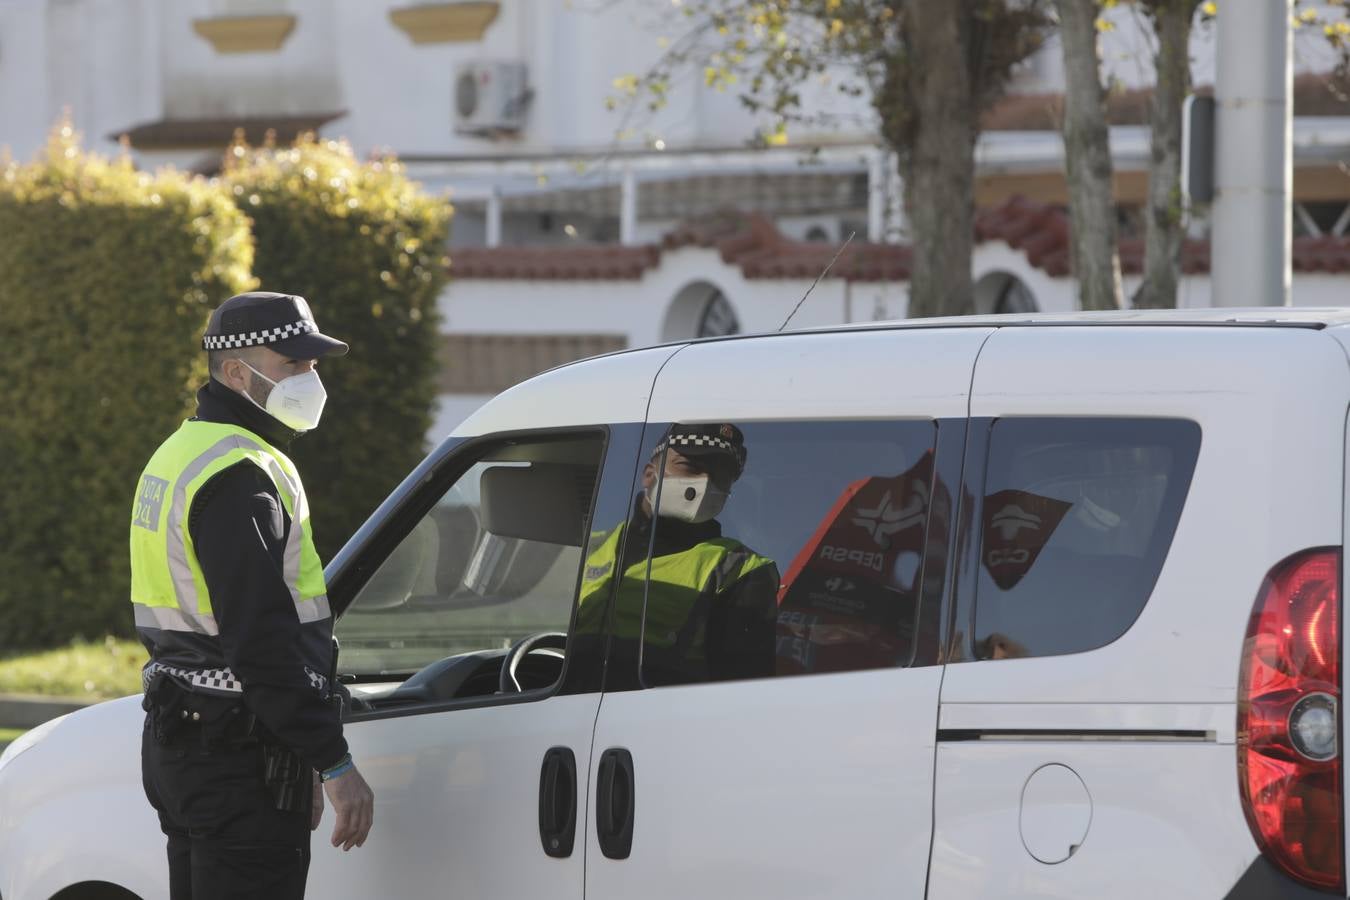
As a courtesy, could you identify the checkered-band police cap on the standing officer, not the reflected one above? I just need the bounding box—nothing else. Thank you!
[201,290,347,359]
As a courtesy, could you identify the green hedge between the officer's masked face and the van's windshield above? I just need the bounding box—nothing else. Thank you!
[223,139,451,561]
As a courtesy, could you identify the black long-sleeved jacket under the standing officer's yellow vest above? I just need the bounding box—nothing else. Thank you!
[150,379,347,770]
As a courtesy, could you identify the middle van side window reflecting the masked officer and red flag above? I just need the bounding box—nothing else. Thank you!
[582,421,937,687]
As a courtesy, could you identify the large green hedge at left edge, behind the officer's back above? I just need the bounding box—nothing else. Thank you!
[0,125,252,649]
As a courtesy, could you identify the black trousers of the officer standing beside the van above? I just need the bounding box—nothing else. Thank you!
[140,719,312,900]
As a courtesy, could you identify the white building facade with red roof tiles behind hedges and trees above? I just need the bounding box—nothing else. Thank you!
[0,0,1350,434]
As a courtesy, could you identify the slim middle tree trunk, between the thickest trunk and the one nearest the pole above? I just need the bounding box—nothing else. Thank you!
[1054,0,1122,309]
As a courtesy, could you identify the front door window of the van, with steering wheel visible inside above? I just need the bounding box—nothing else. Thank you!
[336,433,607,708]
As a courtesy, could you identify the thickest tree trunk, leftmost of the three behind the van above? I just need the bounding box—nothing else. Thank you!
[901,0,979,317]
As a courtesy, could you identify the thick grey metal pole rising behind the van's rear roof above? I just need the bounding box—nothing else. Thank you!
[1210,0,1293,306]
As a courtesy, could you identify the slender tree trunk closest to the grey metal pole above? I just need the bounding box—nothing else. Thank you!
[1134,0,1199,309]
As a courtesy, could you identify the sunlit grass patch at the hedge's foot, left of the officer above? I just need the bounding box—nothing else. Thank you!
[0,637,149,701]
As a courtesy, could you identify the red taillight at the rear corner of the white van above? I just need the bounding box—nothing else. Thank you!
[1238,549,1345,895]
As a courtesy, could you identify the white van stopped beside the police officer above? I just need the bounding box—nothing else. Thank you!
[0,309,1350,900]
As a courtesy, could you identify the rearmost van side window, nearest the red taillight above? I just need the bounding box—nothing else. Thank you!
[973,418,1200,660]
